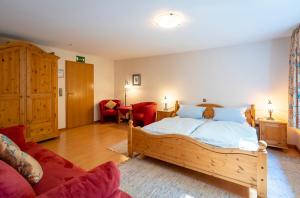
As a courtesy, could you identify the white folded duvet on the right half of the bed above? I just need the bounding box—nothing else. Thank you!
[191,121,258,151]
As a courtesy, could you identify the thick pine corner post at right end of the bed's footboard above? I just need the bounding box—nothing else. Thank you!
[257,140,268,198]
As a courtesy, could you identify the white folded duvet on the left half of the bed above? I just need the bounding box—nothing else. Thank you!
[142,117,206,136]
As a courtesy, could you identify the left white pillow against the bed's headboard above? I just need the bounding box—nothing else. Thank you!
[177,105,205,119]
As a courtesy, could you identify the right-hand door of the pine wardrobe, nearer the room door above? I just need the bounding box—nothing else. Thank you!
[27,50,58,141]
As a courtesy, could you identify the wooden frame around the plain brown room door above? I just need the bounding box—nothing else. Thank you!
[65,60,95,129]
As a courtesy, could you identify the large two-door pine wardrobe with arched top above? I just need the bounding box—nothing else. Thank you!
[0,41,59,141]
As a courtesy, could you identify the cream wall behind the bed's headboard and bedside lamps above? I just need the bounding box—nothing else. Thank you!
[115,38,295,144]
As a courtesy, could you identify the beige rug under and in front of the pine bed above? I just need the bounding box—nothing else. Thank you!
[110,141,300,198]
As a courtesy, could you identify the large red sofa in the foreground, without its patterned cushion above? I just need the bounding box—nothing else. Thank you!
[0,126,130,198]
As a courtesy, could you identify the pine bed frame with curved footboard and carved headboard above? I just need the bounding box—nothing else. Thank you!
[128,102,267,197]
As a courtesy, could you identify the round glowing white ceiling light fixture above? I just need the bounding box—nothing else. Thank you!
[154,11,184,29]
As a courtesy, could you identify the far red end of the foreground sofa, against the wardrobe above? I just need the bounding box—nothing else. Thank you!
[0,125,25,150]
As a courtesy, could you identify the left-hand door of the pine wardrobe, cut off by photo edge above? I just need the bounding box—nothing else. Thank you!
[0,47,26,127]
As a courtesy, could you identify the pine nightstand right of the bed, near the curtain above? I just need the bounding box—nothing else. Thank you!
[259,119,288,149]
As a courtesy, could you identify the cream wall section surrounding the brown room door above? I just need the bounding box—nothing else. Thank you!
[40,45,114,129]
